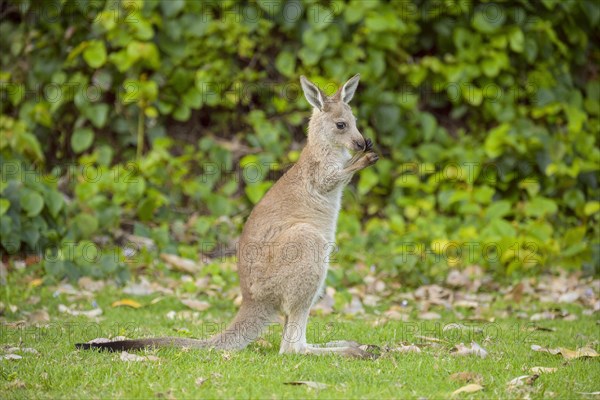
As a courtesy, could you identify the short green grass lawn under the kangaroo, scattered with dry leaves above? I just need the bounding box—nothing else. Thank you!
[0,282,600,399]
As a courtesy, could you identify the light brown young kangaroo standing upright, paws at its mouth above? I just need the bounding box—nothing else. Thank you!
[76,74,379,357]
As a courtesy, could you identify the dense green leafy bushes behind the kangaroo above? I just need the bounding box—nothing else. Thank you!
[0,0,600,284]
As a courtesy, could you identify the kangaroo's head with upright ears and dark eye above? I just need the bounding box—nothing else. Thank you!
[300,74,367,155]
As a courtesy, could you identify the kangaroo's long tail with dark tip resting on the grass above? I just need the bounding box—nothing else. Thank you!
[75,302,274,351]
